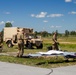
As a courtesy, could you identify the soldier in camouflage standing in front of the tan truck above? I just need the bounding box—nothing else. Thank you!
[17,30,24,57]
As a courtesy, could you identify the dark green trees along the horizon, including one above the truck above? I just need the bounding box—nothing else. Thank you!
[1,22,76,37]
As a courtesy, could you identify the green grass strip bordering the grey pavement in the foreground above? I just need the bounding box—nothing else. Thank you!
[0,56,76,68]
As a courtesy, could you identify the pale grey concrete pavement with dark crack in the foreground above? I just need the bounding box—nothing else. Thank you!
[0,62,76,75]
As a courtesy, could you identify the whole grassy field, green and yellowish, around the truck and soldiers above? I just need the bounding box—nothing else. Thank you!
[0,37,76,68]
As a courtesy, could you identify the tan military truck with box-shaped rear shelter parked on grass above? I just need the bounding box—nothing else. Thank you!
[3,27,43,49]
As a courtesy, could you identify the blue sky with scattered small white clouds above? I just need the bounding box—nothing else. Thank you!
[0,0,76,33]
